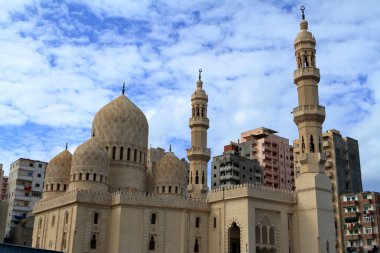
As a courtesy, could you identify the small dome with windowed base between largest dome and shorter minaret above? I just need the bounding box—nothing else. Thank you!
[155,152,186,194]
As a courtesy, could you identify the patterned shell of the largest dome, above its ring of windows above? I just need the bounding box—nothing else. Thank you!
[92,95,148,148]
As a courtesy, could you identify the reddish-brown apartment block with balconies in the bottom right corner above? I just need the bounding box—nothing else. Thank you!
[340,192,380,252]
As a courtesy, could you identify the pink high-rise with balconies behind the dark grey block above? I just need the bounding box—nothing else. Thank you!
[240,127,294,190]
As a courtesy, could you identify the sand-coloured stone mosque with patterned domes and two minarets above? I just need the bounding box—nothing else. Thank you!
[33,7,336,253]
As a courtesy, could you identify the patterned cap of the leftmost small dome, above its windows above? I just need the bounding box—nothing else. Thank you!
[45,150,73,183]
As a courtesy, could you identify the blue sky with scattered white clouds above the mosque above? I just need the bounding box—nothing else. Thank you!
[0,0,380,191]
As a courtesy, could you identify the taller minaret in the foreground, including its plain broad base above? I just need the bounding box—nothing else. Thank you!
[293,6,336,253]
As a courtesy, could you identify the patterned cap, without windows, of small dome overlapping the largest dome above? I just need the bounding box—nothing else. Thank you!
[71,138,109,175]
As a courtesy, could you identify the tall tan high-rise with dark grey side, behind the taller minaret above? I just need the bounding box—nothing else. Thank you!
[294,129,363,252]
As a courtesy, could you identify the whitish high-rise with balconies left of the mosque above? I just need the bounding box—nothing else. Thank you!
[5,158,47,246]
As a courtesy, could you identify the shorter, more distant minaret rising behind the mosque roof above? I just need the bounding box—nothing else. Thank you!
[187,69,210,198]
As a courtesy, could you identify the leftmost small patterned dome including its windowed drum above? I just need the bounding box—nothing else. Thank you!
[43,150,72,198]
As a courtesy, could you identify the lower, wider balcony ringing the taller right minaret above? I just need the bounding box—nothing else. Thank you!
[292,105,326,124]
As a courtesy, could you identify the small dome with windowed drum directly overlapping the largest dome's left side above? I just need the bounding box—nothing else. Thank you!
[70,138,109,189]
